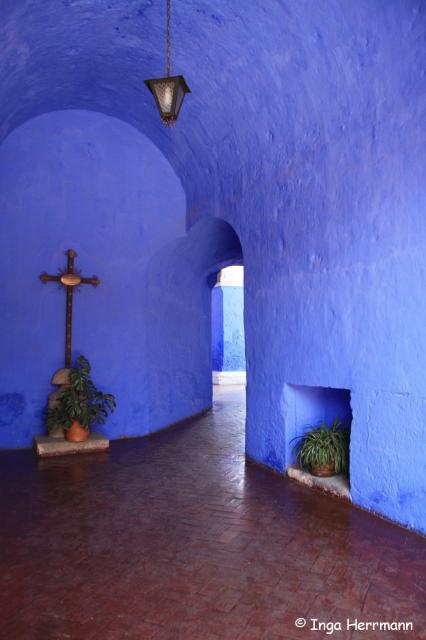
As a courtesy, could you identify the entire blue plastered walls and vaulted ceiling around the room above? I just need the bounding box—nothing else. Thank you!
[0,0,426,531]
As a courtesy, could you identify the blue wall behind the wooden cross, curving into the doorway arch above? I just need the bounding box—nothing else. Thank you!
[0,111,241,448]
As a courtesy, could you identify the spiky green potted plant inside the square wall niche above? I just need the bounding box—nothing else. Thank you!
[297,418,349,478]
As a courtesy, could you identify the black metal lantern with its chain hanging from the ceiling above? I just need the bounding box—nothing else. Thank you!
[145,0,191,125]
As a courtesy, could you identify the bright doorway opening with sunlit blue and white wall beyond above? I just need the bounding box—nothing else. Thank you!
[211,265,246,386]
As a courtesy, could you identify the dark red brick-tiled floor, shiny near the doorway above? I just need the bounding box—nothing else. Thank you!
[0,388,426,640]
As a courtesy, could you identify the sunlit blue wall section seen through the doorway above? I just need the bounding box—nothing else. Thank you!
[212,285,246,371]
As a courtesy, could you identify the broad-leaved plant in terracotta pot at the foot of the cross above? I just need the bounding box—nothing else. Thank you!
[46,356,116,442]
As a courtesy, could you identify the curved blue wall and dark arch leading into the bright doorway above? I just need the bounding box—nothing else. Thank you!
[146,218,243,430]
